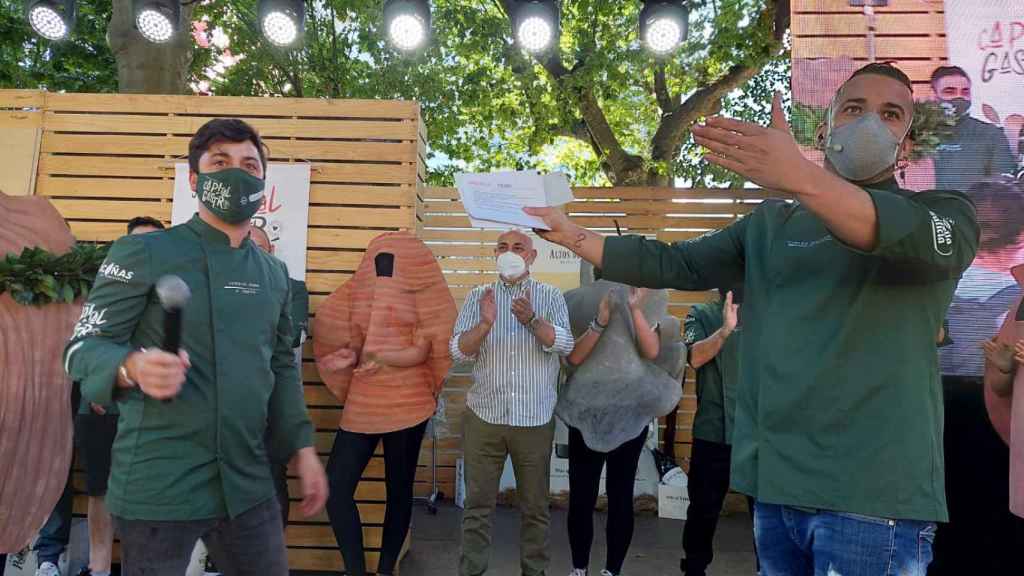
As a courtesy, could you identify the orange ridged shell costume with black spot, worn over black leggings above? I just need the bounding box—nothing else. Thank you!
[312,232,458,434]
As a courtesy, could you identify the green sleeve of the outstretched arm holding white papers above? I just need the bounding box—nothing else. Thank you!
[601,212,757,290]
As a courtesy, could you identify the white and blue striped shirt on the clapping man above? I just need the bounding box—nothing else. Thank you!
[450,278,574,426]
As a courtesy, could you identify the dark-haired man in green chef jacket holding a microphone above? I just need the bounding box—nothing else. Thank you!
[63,119,327,576]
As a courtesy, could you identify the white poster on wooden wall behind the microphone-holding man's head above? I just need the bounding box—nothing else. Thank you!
[171,163,309,281]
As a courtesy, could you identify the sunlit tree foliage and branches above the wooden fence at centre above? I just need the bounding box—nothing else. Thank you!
[198,0,788,184]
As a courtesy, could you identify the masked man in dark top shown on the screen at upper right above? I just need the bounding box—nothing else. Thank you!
[932,66,1017,192]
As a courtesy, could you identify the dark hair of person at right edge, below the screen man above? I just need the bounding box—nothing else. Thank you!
[967,176,1024,251]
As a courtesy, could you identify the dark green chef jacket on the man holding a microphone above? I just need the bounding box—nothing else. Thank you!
[65,216,312,521]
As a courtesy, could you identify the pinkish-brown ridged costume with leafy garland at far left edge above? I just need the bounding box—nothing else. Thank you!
[0,193,82,549]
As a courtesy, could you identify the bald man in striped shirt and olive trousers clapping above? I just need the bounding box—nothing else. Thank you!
[450,231,573,576]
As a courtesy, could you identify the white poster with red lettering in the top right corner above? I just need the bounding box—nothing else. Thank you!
[945,0,1024,136]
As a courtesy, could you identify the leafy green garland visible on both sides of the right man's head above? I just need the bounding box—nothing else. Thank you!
[792,100,956,161]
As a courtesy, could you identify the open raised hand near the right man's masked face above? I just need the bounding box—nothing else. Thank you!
[692,92,816,194]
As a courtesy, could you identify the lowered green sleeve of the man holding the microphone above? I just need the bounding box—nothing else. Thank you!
[267,264,313,462]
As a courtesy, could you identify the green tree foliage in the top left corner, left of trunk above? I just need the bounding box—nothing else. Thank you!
[0,0,118,92]
